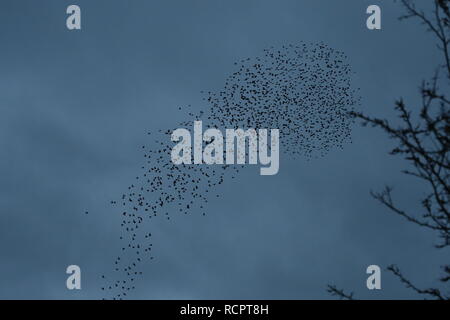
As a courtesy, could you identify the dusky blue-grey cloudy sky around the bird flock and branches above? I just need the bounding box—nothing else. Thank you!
[0,0,448,299]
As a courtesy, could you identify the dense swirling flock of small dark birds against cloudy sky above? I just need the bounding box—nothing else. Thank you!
[97,43,359,299]
